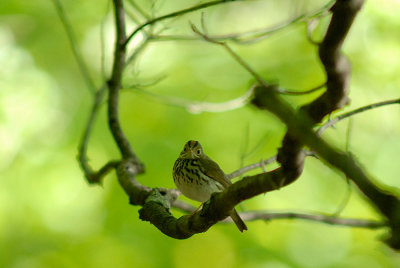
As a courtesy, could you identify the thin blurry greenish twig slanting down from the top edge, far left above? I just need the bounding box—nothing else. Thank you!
[53,0,96,95]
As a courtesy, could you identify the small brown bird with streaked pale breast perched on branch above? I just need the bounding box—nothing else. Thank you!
[172,140,247,232]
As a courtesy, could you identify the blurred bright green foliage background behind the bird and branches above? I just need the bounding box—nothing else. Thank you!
[0,0,400,268]
